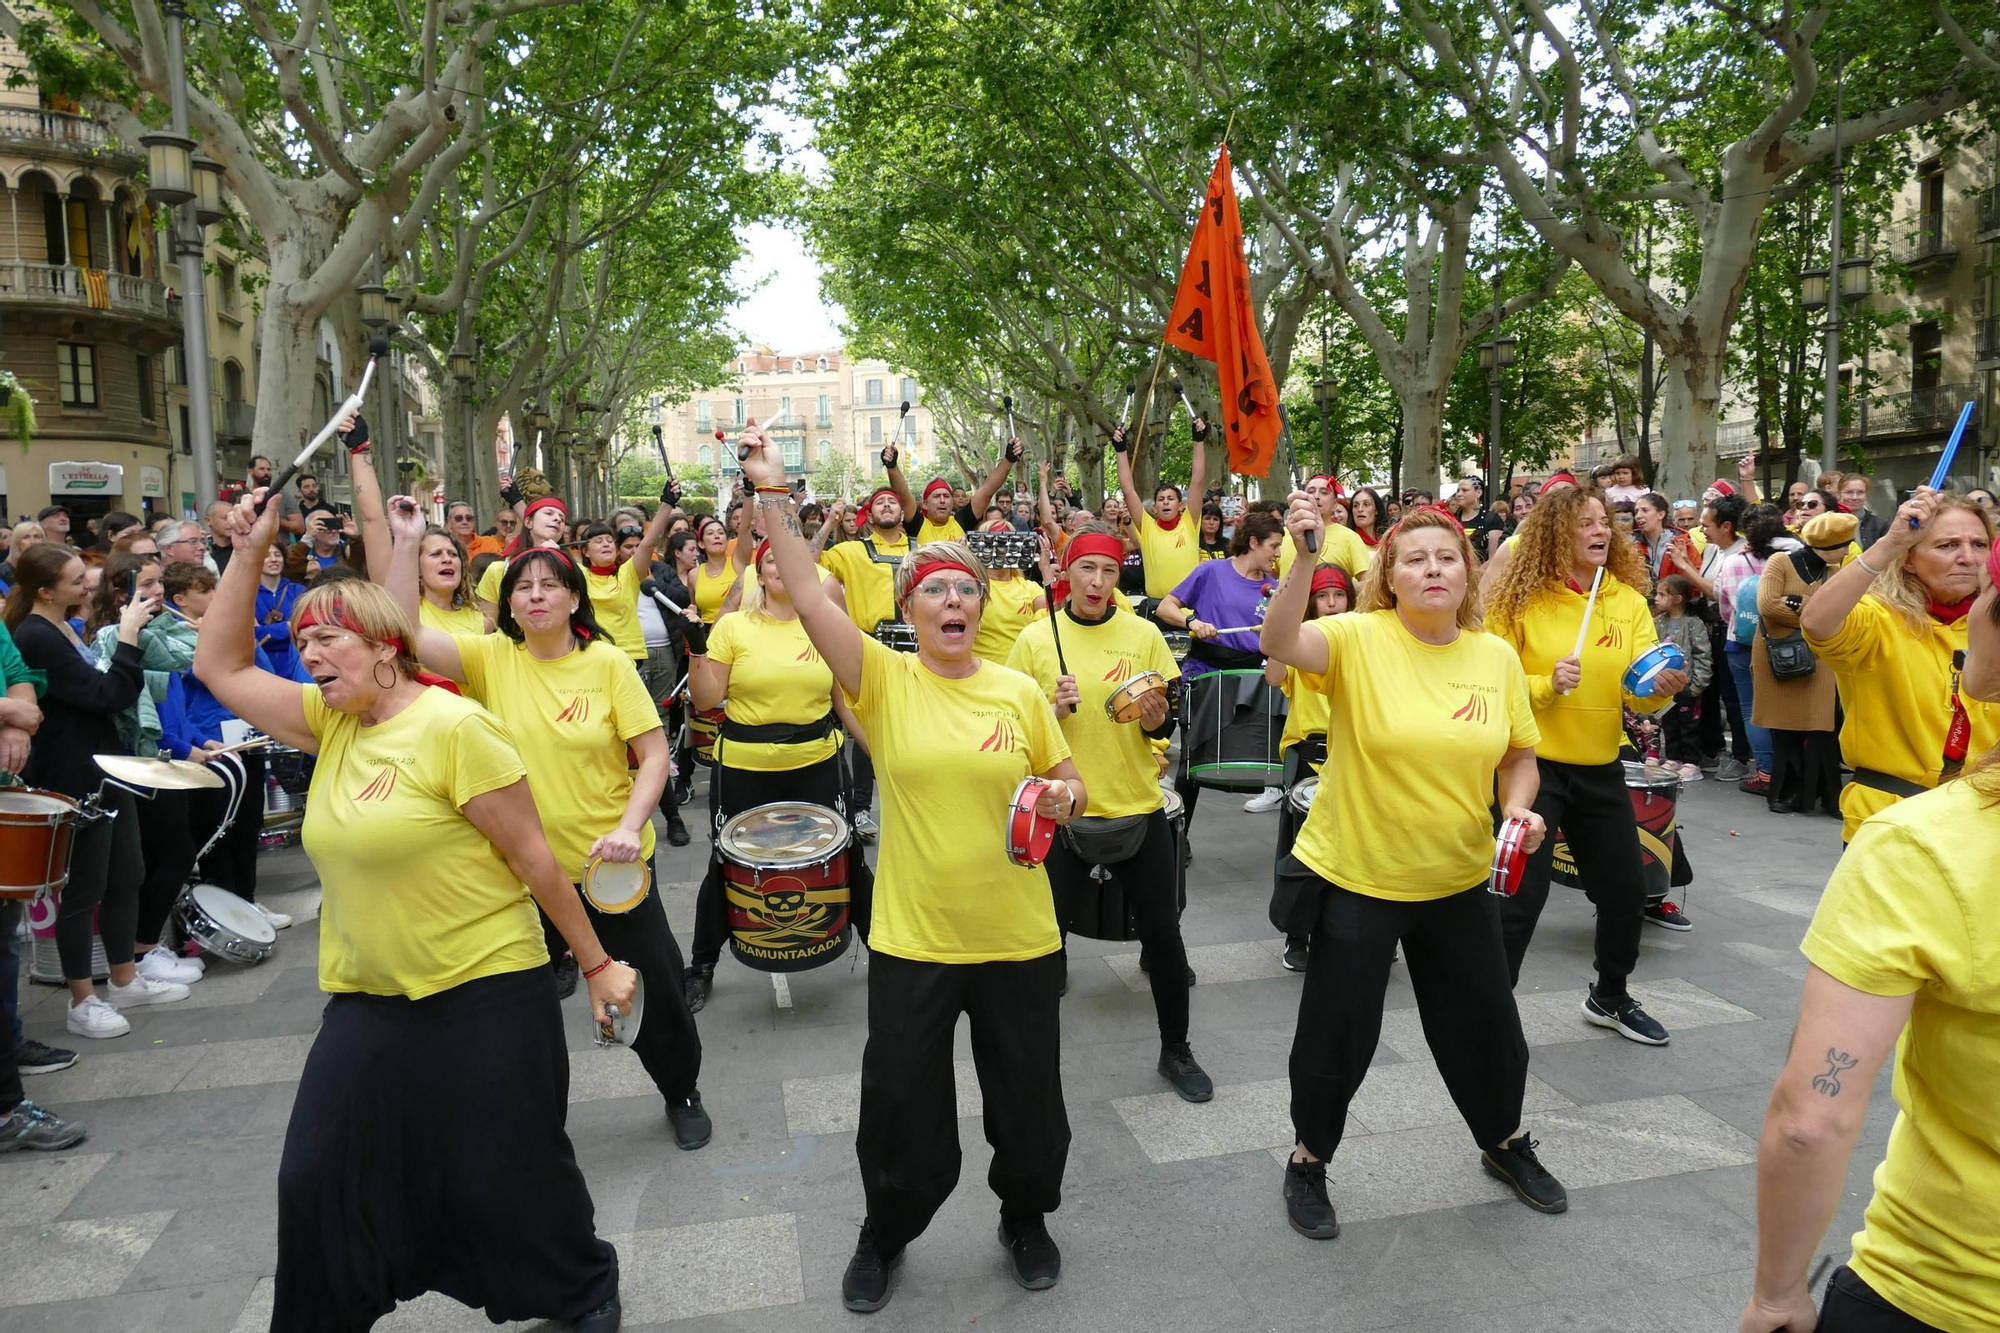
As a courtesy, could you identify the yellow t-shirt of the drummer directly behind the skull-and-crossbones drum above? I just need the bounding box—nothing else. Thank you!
[708,614,840,773]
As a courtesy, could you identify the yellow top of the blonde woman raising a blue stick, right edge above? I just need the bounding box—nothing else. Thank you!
[1806,592,2000,841]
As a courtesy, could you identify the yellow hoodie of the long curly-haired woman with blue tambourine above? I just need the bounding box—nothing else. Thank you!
[1486,572,1674,765]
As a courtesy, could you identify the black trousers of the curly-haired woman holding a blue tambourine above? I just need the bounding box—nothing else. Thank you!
[1500,759,1646,999]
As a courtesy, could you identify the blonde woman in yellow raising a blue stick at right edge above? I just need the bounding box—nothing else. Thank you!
[1798,486,2000,841]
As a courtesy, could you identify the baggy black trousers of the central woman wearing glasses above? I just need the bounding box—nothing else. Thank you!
[854,953,1070,1255]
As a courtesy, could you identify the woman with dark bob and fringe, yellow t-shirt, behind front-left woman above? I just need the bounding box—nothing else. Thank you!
[388,496,712,1149]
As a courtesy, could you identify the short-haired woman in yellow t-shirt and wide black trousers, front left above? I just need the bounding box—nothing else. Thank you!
[194,490,636,1329]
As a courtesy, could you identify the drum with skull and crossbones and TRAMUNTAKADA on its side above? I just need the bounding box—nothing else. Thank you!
[716,801,852,973]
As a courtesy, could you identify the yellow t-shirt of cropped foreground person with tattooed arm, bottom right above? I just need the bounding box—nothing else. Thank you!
[1804,781,2000,1329]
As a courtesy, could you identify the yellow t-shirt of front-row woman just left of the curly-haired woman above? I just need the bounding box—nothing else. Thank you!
[1292,610,1542,903]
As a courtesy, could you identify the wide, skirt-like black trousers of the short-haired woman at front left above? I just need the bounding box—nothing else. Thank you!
[270,967,618,1333]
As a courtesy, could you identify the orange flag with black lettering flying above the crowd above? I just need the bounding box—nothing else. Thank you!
[1166,144,1280,476]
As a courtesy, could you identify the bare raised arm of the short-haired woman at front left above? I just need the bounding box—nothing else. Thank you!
[194,486,320,755]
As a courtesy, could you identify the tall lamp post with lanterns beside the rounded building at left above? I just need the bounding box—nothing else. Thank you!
[140,0,222,510]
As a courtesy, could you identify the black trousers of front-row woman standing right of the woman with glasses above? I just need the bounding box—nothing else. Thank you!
[1286,861,1528,1161]
